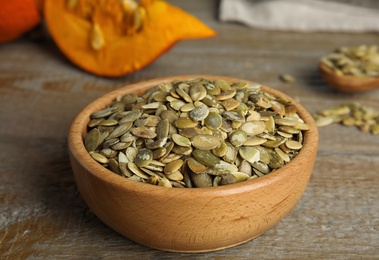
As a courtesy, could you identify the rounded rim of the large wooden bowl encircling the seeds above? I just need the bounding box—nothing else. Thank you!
[67,75,319,197]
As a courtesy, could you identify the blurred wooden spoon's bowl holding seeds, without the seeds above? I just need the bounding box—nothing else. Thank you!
[320,63,379,93]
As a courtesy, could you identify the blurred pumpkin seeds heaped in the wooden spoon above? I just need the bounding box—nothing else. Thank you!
[321,45,379,77]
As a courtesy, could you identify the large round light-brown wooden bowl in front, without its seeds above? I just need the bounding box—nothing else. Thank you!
[68,75,318,252]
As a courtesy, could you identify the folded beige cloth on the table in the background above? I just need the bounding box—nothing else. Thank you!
[219,0,379,32]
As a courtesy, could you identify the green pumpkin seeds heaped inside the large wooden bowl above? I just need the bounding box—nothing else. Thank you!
[84,78,309,188]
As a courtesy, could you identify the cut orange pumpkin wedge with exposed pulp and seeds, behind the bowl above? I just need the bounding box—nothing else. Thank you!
[44,0,216,77]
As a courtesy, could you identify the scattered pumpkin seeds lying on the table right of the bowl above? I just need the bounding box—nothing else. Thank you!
[314,103,379,135]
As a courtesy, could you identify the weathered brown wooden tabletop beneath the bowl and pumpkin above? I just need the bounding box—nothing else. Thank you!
[0,0,379,259]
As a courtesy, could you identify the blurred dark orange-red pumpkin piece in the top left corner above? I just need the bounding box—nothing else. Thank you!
[0,0,41,43]
